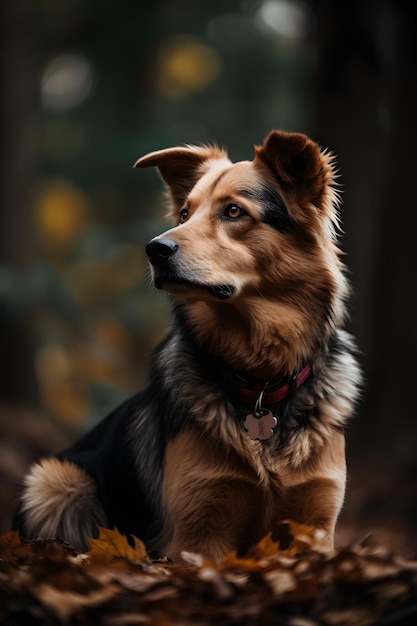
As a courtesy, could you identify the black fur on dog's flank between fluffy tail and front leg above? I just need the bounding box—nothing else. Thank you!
[54,392,165,552]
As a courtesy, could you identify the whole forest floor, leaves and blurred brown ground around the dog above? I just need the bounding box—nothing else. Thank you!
[0,407,417,626]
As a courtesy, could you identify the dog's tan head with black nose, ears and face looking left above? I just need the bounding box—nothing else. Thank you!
[135,130,345,370]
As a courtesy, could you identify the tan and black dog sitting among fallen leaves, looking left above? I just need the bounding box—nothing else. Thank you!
[15,130,361,561]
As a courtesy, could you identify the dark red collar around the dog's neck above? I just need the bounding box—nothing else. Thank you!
[226,365,311,406]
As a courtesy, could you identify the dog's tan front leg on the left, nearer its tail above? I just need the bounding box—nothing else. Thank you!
[164,432,264,561]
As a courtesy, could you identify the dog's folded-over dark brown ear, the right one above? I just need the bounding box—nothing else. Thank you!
[255,130,328,201]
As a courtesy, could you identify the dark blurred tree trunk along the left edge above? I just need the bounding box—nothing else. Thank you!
[0,0,37,404]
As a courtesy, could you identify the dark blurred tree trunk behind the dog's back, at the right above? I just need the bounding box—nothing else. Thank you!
[315,0,417,462]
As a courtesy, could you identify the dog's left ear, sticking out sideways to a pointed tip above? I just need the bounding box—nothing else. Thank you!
[134,146,227,209]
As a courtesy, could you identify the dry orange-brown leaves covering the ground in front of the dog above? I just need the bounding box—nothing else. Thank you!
[0,522,417,626]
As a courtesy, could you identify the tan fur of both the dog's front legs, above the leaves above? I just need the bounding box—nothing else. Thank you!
[164,431,346,560]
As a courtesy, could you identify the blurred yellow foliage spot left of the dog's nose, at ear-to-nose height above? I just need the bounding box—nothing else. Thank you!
[36,180,89,253]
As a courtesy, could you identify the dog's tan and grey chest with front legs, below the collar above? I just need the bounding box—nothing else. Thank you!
[151,324,356,559]
